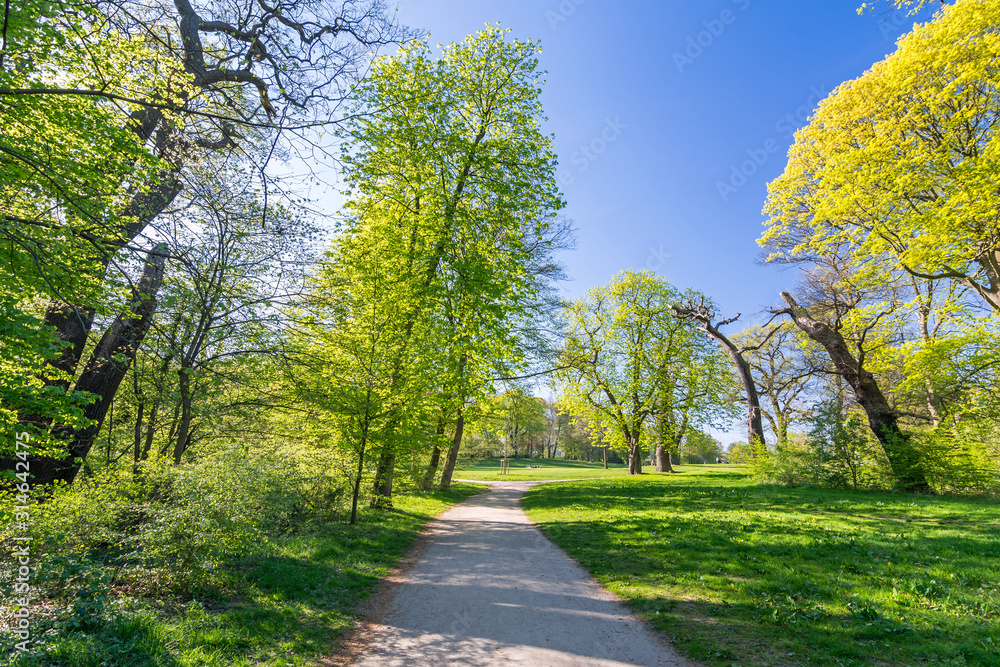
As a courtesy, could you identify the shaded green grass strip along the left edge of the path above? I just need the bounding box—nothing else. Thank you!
[0,483,483,667]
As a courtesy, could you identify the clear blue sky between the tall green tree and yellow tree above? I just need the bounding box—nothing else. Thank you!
[386,0,932,441]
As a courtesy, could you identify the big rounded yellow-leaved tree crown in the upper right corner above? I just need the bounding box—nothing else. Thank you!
[761,0,1000,311]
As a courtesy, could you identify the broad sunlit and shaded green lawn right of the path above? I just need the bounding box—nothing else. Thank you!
[523,465,1000,666]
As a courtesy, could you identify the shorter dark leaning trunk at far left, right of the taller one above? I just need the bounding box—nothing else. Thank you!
[18,245,166,484]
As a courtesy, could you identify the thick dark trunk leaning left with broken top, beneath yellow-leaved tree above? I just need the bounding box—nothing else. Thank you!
[781,292,930,492]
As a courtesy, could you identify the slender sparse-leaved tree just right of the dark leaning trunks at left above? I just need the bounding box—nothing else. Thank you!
[155,159,308,463]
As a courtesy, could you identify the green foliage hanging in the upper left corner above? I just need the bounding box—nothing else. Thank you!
[0,0,182,305]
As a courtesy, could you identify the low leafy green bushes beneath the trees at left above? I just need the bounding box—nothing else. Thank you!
[0,440,354,631]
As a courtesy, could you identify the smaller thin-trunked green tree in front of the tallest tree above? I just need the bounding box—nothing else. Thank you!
[287,223,443,523]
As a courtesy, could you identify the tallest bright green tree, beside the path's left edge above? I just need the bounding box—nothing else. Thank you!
[328,27,563,504]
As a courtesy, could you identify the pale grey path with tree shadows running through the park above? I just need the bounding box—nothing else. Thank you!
[355,482,691,667]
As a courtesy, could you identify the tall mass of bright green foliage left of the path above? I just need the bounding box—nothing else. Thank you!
[286,26,566,506]
